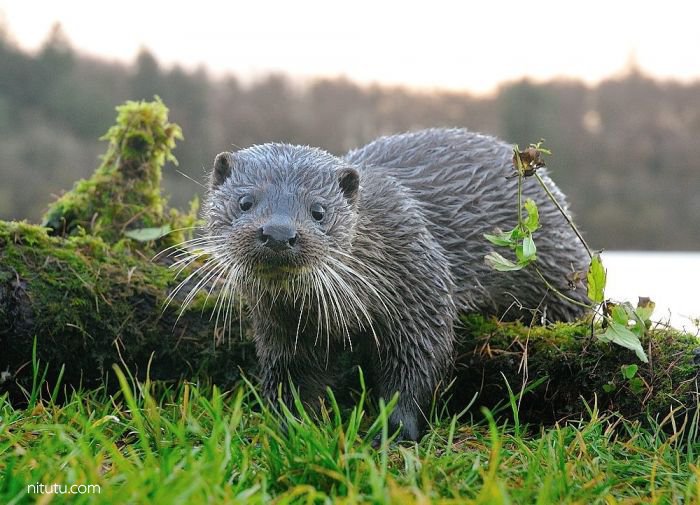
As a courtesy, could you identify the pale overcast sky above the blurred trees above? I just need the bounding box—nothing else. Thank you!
[0,0,700,92]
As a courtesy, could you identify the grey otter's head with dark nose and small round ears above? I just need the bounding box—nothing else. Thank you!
[205,144,359,287]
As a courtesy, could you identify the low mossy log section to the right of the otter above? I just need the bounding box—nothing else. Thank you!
[455,314,700,422]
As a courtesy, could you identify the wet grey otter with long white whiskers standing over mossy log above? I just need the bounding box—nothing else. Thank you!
[200,129,588,440]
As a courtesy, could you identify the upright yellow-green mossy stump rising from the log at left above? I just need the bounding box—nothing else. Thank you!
[42,98,197,244]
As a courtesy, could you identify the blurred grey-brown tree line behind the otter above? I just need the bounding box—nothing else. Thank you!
[0,26,700,250]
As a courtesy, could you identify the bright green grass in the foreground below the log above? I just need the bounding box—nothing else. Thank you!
[0,366,700,504]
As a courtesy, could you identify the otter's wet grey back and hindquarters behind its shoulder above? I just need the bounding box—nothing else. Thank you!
[345,129,587,319]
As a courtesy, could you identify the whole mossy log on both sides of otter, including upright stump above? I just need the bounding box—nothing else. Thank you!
[0,102,698,422]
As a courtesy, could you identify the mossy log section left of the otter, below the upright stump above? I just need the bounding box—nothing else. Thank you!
[0,221,253,398]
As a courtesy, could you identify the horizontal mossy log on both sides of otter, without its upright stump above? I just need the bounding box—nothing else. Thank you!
[0,227,700,422]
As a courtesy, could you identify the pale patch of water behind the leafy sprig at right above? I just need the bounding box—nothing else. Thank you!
[602,251,700,334]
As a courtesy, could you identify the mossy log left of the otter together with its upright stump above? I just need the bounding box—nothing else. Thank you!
[0,100,253,398]
